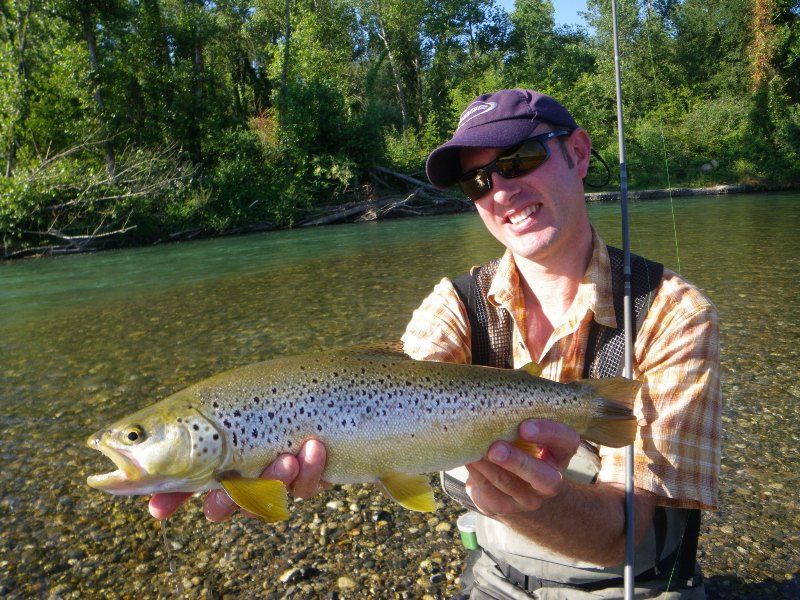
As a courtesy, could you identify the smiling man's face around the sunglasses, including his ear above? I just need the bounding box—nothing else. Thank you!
[460,124,591,262]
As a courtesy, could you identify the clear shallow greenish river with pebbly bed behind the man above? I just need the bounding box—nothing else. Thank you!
[0,193,800,598]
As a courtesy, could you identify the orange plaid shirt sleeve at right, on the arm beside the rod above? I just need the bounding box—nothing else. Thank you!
[598,280,722,509]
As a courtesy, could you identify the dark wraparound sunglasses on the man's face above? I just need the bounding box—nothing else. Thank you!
[458,129,572,201]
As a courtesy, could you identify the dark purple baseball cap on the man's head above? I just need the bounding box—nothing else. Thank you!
[425,89,578,189]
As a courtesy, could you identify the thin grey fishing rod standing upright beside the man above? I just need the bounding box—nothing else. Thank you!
[611,0,636,600]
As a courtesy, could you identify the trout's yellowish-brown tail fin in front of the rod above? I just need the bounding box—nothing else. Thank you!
[579,377,642,448]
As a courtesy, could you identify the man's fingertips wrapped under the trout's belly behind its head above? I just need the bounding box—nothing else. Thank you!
[149,440,327,522]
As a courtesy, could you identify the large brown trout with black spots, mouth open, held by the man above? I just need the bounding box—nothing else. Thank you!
[87,346,640,522]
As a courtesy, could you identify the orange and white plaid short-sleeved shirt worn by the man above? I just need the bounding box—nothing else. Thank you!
[402,232,721,509]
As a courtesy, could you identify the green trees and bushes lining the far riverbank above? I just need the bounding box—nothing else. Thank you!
[0,0,800,251]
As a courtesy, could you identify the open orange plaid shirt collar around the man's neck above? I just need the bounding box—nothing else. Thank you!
[486,227,617,333]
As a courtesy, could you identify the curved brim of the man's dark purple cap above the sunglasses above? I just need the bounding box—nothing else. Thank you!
[425,119,539,189]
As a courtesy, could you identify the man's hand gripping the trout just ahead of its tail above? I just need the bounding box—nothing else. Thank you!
[466,419,581,516]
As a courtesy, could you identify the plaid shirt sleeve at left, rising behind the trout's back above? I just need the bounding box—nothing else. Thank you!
[401,278,472,364]
